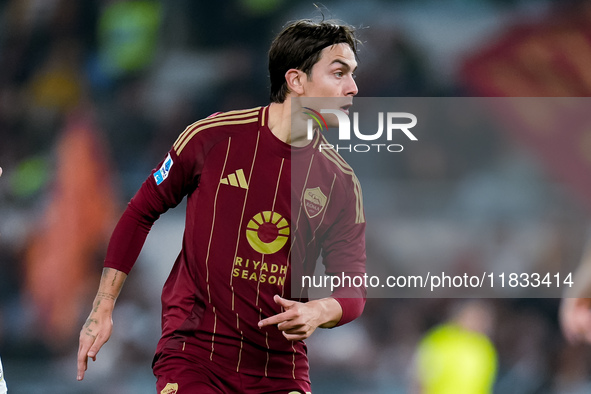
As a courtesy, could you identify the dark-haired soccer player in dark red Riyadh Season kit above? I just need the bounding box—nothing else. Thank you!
[78,16,365,394]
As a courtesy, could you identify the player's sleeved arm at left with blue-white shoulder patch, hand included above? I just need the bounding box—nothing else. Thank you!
[77,124,203,380]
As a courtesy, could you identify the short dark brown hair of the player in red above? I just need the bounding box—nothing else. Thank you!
[269,19,359,103]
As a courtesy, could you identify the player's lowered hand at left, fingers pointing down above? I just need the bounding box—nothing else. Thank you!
[76,311,113,380]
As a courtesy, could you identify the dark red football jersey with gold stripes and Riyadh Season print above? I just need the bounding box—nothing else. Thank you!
[105,107,365,380]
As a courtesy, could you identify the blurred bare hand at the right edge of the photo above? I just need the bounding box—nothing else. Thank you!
[559,298,591,343]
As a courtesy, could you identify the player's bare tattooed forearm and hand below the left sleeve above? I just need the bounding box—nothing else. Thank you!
[77,268,127,380]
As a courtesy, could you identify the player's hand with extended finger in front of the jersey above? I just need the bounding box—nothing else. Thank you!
[259,295,340,341]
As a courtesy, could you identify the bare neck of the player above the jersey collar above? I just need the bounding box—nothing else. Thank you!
[269,97,310,146]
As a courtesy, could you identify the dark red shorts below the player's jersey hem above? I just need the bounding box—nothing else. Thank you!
[154,349,312,394]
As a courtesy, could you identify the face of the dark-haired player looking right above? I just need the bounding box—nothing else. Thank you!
[303,43,357,114]
